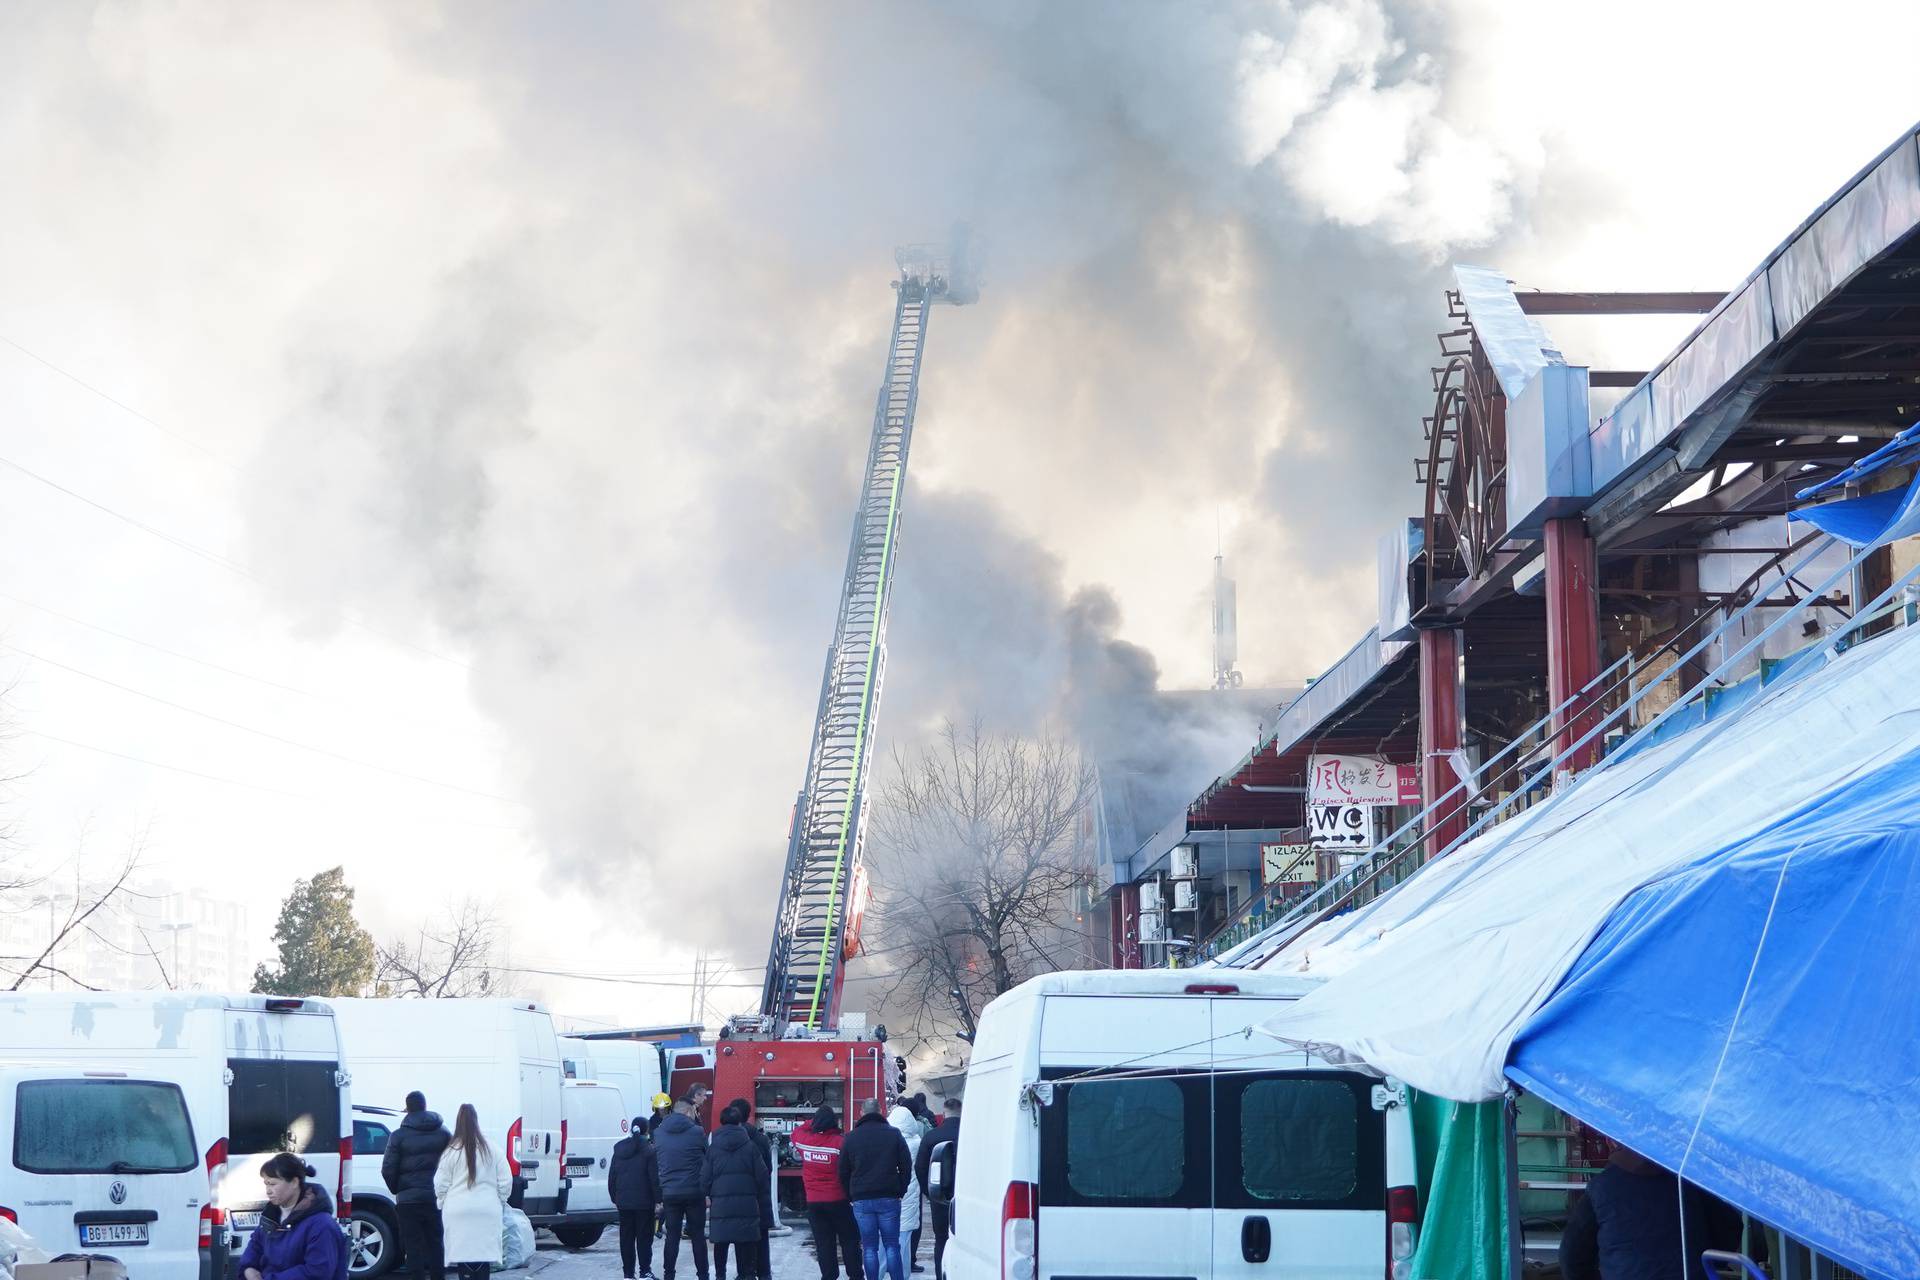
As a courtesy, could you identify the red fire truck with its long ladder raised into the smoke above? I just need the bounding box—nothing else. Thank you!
[698,238,979,1207]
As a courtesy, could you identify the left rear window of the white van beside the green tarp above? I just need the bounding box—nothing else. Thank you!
[1041,1071,1212,1209]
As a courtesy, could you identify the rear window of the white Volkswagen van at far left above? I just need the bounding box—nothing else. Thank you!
[13,1080,200,1173]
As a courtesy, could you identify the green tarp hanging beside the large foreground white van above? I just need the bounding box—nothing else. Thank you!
[1413,1092,1511,1280]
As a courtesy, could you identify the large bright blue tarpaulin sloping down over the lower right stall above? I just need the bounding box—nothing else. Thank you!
[1507,752,1920,1280]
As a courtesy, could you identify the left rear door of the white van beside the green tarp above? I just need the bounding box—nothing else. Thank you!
[1044,996,1213,1280]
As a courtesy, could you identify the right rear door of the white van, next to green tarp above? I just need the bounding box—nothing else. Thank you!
[1212,996,1386,1280]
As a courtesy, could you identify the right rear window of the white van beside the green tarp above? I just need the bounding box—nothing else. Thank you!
[1215,1071,1386,1209]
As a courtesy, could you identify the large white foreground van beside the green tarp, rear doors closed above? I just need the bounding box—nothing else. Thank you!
[947,969,1417,1280]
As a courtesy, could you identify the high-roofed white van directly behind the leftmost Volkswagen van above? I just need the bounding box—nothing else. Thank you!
[0,992,353,1278]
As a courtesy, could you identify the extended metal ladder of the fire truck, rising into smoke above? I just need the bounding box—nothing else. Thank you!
[760,249,972,1031]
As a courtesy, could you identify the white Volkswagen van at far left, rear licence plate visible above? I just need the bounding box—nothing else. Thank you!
[0,1063,206,1280]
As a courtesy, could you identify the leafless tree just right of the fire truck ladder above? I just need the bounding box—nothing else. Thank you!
[870,720,1092,1038]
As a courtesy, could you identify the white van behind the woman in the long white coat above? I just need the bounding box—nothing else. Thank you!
[332,1000,566,1226]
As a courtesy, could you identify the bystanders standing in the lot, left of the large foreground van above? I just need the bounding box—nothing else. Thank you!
[234,1084,960,1280]
